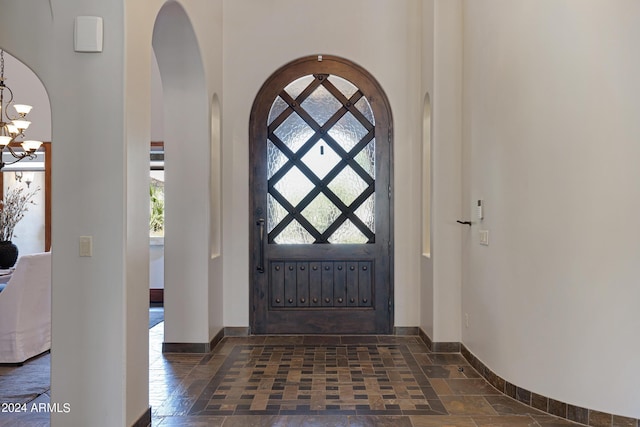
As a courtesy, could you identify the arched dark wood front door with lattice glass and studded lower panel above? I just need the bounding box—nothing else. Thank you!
[249,56,393,334]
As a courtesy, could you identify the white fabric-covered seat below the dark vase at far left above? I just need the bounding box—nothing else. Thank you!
[0,252,51,364]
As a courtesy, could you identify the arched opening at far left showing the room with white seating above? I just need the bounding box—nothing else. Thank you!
[0,47,52,418]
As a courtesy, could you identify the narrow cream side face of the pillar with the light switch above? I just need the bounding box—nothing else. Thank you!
[124,2,155,425]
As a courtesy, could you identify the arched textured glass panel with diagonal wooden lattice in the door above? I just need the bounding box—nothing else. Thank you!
[266,75,376,244]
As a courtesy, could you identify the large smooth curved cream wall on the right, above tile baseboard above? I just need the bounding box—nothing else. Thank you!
[463,0,640,418]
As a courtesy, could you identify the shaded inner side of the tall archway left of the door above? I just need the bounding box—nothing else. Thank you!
[153,2,211,343]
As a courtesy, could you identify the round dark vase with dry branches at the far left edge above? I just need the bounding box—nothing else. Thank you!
[0,187,40,269]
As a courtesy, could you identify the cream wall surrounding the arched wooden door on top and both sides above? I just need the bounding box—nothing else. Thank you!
[222,0,422,326]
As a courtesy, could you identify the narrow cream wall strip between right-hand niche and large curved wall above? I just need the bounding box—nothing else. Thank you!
[417,0,466,342]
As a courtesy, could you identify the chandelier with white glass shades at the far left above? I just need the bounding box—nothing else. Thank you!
[0,50,42,170]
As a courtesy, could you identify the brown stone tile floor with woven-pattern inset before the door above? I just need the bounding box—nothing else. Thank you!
[149,325,579,427]
